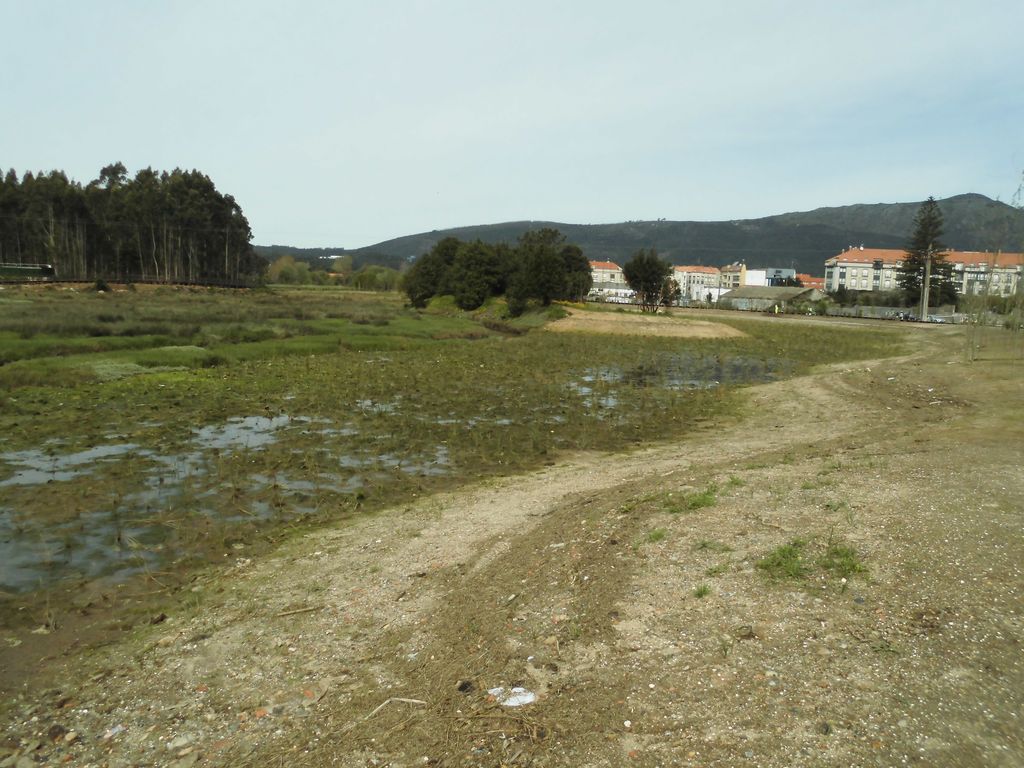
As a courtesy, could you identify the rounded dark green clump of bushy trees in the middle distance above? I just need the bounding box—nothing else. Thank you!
[402,227,593,315]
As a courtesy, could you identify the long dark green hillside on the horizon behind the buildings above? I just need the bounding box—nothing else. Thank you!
[256,195,1024,274]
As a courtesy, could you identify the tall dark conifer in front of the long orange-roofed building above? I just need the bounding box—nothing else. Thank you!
[896,198,956,306]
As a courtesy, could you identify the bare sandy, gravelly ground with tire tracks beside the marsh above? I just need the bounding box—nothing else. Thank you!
[0,331,1024,768]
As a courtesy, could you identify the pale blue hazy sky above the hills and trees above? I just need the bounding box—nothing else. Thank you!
[0,0,1024,248]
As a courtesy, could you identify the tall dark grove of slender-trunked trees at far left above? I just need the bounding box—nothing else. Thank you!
[0,163,265,282]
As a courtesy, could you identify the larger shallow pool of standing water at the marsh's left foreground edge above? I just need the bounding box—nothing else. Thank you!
[0,417,449,593]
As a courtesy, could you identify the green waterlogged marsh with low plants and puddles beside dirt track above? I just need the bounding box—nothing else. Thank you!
[0,287,897,606]
